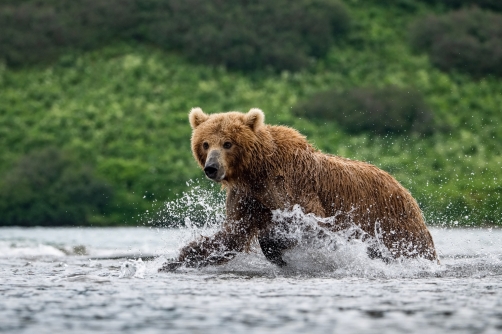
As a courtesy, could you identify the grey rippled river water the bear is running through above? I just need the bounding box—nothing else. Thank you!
[0,227,502,333]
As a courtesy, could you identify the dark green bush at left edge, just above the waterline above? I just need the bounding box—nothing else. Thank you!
[0,148,113,226]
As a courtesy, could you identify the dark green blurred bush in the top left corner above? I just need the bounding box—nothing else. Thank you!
[0,0,138,65]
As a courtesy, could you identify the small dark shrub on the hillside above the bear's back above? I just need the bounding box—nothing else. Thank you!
[293,86,433,134]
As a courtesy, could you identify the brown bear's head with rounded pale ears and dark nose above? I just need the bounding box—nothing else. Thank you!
[189,108,266,183]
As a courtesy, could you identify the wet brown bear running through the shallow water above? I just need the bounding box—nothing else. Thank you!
[160,108,437,271]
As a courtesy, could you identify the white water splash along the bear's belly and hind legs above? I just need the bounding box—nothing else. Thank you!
[218,206,444,278]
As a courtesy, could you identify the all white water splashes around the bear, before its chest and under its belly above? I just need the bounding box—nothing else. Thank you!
[154,187,452,277]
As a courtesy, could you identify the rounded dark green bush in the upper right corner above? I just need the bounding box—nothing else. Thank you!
[410,8,502,77]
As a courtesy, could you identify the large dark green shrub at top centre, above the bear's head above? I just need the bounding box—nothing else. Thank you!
[143,0,349,70]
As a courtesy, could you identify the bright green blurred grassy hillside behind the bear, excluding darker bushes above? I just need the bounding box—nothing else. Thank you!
[0,0,502,224]
